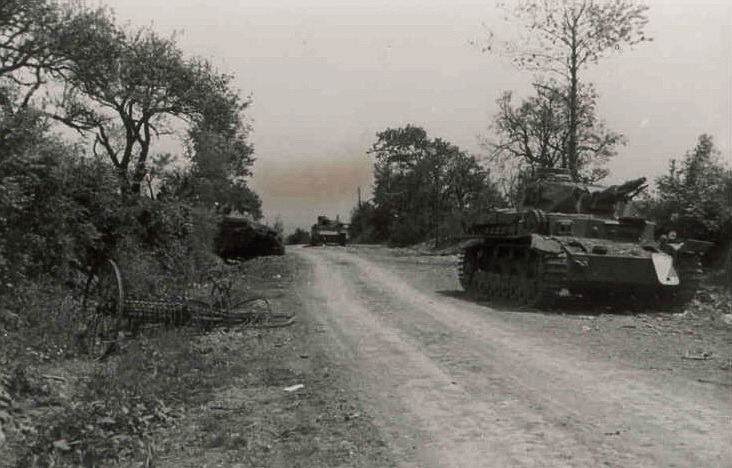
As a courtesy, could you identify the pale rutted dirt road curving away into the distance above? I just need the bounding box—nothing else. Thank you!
[290,247,732,467]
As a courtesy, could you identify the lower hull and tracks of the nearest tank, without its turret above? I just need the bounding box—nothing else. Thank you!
[458,234,701,308]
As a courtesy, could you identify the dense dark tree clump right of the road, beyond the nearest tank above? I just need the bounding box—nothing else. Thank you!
[366,125,500,249]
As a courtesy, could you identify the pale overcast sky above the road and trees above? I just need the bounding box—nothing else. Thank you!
[102,0,732,230]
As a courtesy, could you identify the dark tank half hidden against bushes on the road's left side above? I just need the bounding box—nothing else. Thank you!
[214,215,285,260]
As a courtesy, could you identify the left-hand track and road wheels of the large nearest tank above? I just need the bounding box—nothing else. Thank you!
[458,247,567,309]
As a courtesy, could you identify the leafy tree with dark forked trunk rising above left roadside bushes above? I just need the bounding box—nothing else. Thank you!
[52,8,249,194]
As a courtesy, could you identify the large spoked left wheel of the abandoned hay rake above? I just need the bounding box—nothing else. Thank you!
[79,260,125,360]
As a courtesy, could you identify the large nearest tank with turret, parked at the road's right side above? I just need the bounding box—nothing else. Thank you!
[458,169,711,308]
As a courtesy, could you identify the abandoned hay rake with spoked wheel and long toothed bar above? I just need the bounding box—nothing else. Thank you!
[79,259,294,360]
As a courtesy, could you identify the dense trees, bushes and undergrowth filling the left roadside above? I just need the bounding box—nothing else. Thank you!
[0,0,262,467]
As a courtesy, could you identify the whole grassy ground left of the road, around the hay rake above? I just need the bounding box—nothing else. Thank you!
[0,247,393,468]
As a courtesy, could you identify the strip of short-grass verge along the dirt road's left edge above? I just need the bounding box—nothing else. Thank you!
[142,255,394,468]
